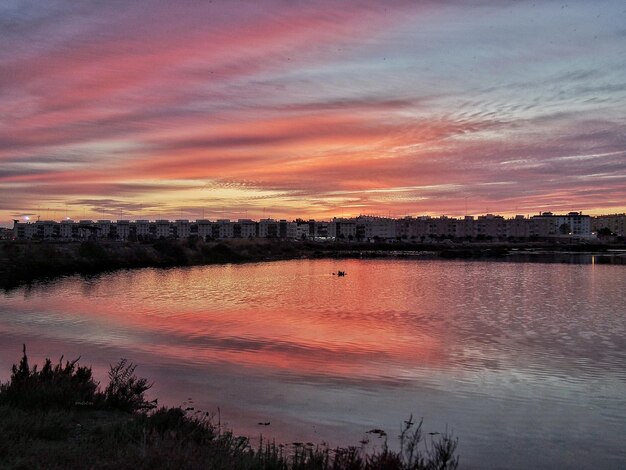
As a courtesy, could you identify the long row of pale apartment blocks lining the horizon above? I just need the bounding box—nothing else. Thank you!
[12,212,596,242]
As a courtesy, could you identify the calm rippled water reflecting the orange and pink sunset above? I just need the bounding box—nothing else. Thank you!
[0,260,626,469]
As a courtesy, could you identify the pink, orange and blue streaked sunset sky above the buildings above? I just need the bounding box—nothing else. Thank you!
[0,0,626,225]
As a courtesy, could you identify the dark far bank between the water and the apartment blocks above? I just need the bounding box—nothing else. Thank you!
[0,239,626,289]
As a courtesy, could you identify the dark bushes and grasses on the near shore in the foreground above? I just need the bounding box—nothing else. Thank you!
[0,348,459,470]
